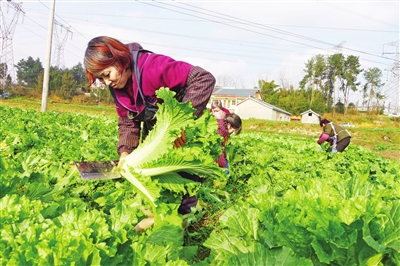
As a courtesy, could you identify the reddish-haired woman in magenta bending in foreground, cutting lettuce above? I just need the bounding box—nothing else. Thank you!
[84,36,215,231]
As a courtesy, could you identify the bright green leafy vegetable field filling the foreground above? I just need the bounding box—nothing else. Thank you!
[0,106,400,266]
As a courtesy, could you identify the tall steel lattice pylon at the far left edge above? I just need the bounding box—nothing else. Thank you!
[0,0,25,92]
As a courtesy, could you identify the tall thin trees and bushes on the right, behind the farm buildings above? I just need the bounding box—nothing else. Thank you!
[258,53,384,114]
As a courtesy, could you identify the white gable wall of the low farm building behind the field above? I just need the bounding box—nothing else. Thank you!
[236,101,276,120]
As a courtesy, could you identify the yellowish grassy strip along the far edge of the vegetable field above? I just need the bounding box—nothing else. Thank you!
[0,97,400,161]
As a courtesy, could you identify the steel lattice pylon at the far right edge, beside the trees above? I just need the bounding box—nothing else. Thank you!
[382,40,400,114]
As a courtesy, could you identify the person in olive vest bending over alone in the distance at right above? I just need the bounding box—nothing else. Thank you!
[317,119,351,153]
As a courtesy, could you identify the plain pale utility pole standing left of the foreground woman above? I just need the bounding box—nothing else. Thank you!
[40,0,56,112]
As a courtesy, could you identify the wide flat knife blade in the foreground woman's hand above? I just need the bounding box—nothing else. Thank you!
[74,160,121,180]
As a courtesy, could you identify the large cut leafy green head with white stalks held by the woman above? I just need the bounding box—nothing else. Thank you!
[118,88,226,210]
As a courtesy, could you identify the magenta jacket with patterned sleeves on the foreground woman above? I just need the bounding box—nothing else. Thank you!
[111,48,215,154]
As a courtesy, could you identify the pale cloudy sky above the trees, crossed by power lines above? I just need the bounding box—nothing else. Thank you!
[1,0,399,108]
